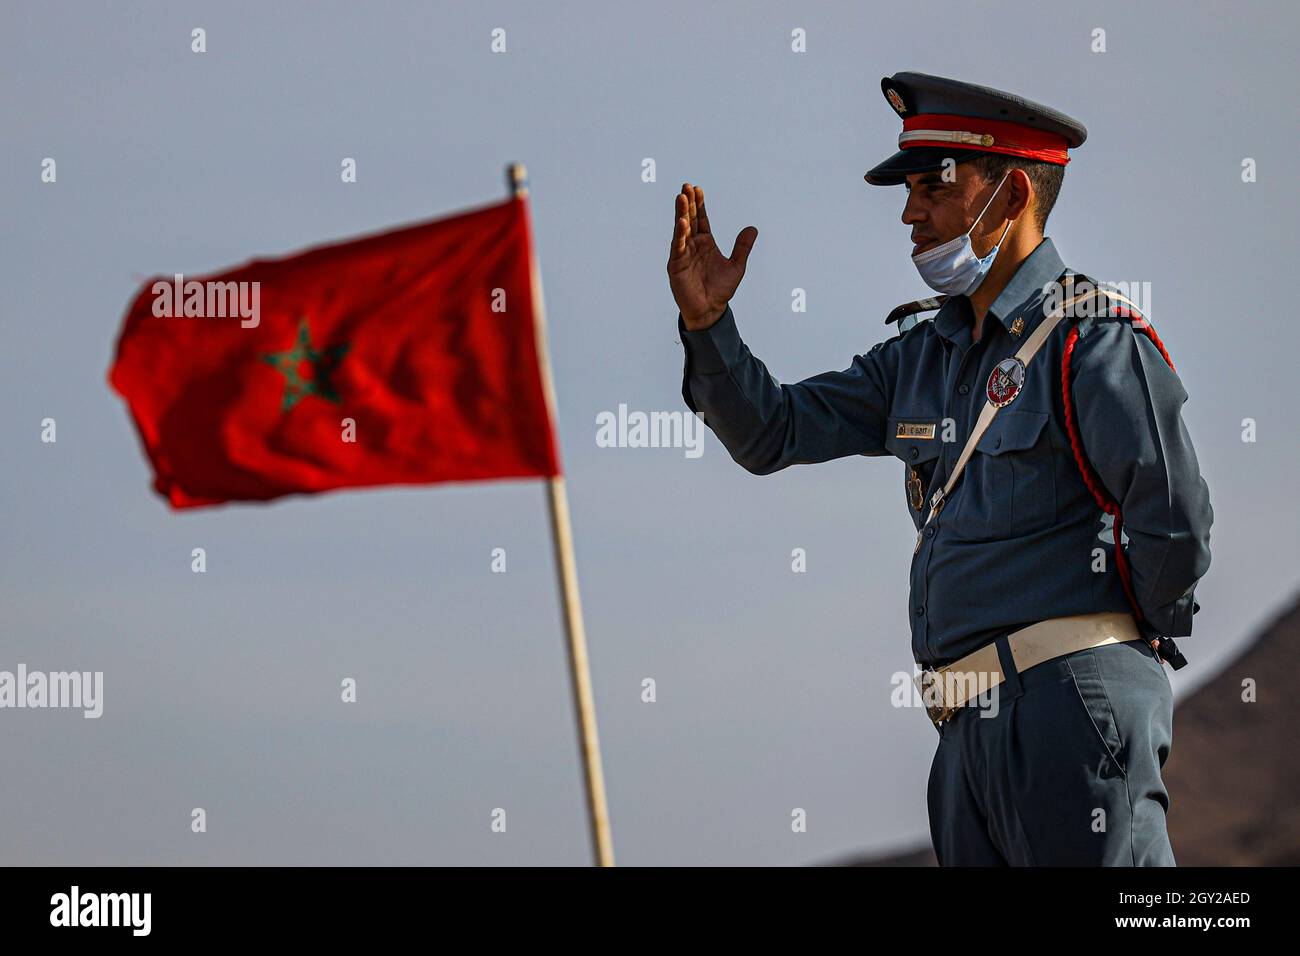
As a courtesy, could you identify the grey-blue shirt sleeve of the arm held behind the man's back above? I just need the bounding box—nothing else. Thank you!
[1071,320,1214,637]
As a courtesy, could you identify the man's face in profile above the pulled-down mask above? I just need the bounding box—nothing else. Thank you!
[902,163,1015,255]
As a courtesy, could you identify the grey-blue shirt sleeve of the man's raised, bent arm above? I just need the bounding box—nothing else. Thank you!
[677,306,897,475]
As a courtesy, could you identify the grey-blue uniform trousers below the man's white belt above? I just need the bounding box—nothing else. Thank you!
[927,637,1177,866]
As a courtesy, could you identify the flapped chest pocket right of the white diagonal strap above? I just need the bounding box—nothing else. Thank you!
[953,408,1057,540]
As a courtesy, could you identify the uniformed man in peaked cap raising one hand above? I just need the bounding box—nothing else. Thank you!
[668,73,1213,866]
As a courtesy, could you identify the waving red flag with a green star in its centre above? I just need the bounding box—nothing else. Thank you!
[109,196,559,509]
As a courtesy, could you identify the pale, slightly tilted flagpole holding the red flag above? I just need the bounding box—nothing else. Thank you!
[506,163,614,866]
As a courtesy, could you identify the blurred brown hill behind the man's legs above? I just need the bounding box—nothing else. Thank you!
[833,596,1300,866]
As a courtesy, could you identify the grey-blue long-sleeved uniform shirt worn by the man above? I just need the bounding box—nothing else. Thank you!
[677,239,1214,666]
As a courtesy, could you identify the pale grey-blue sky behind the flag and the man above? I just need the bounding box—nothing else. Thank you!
[0,0,1300,865]
